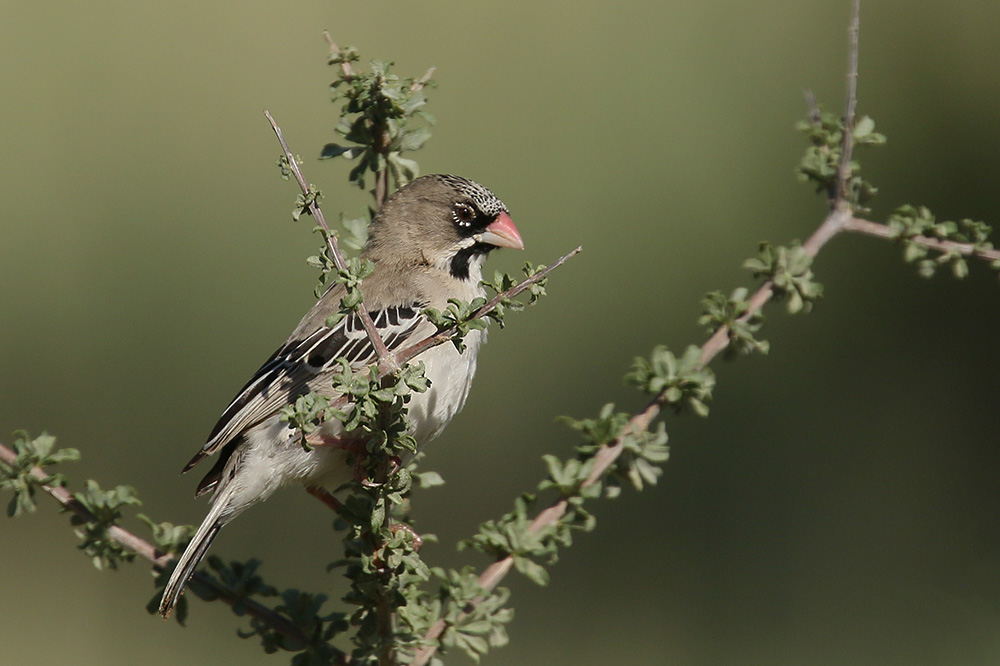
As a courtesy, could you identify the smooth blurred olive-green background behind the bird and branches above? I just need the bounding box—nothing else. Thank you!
[0,0,1000,666]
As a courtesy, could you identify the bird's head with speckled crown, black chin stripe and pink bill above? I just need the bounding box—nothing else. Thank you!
[365,174,524,283]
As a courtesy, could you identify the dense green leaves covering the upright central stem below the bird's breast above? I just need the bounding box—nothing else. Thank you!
[289,359,439,664]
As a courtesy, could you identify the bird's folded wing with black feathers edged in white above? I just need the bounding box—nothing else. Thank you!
[184,303,433,472]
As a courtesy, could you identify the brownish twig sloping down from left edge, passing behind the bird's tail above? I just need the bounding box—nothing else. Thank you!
[0,444,336,652]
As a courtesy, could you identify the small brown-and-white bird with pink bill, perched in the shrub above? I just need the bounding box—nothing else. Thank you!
[160,175,524,617]
